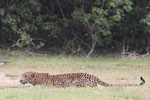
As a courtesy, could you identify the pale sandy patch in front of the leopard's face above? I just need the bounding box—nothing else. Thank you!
[0,72,20,86]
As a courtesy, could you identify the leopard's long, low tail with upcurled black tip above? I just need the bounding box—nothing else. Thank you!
[98,77,146,87]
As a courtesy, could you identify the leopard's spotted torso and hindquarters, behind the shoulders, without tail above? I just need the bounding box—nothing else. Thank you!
[51,73,99,87]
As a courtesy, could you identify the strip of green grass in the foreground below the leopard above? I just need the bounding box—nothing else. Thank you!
[0,87,140,100]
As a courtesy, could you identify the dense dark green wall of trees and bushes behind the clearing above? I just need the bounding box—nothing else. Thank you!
[0,0,150,56]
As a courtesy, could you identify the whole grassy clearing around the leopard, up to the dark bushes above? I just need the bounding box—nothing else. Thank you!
[0,54,150,100]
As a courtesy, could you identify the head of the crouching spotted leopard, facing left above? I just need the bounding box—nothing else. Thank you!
[20,72,36,85]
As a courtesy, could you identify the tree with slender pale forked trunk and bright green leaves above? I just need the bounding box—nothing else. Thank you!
[73,0,132,57]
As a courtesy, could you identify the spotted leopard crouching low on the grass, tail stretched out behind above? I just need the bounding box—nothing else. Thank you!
[20,72,145,87]
